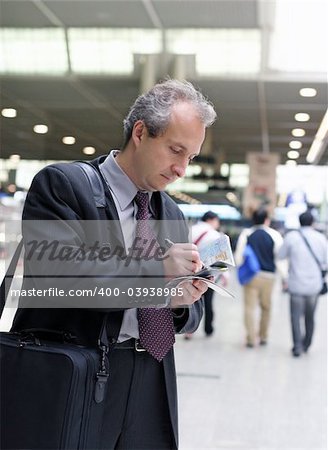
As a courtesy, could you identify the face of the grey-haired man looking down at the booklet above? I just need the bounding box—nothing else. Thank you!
[132,103,205,191]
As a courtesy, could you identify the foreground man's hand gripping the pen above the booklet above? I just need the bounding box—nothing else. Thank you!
[163,243,202,278]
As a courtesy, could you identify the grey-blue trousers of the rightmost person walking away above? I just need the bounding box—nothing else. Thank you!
[290,294,318,353]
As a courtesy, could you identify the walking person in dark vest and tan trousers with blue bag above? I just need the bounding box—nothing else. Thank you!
[235,208,283,348]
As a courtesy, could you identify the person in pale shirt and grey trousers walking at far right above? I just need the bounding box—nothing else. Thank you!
[278,211,328,357]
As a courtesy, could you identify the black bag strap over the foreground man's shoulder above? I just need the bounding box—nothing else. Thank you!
[0,161,107,317]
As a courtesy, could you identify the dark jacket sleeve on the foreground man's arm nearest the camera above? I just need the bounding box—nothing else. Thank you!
[23,165,164,310]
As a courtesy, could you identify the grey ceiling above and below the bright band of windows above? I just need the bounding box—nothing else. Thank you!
[0,0,327,168]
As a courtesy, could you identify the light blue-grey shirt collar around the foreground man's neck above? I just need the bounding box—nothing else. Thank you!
[99,150,152,211]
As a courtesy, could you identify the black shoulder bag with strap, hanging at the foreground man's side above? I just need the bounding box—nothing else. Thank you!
[0,163,118,450]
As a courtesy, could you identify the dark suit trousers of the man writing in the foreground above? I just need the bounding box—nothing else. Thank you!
[101,342,176,450]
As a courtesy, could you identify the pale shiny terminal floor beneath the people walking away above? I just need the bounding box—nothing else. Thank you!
[175,277,327,450]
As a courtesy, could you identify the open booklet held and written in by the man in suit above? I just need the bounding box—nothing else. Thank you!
[167,234,235,298]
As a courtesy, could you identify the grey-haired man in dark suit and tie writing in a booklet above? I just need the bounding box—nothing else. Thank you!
[13,80,216,450]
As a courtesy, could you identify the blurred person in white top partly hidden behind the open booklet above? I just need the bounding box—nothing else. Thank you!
[185,211,227,339]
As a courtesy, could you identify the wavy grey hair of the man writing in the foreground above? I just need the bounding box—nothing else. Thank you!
[123,80,216,148]
